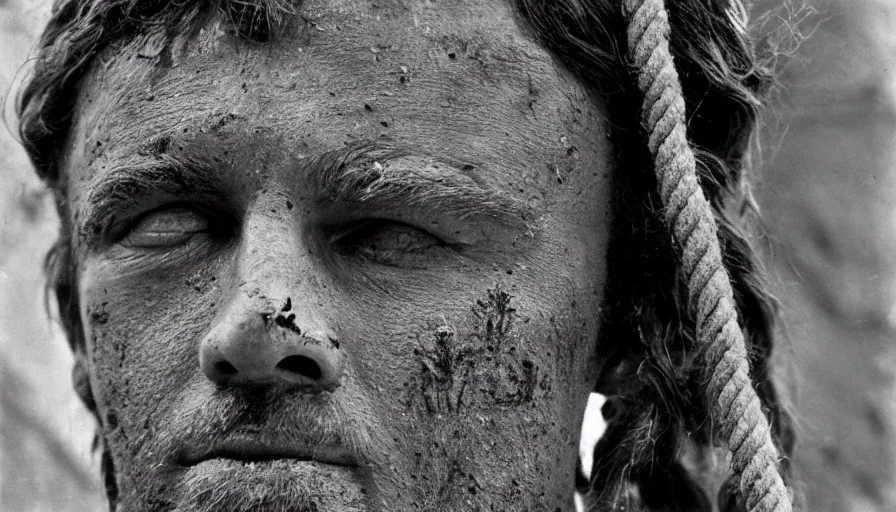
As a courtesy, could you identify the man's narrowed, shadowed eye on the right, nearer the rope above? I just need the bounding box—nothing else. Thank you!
[338,219,448,268]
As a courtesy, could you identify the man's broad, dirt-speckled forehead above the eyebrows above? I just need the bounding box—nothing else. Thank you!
[69,0,603,214]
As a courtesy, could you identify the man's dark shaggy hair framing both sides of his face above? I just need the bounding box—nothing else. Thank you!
[17,0,794,511]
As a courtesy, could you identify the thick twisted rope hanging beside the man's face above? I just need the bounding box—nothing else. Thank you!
[623,0,793,512]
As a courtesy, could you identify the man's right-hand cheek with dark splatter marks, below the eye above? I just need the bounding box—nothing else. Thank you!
[338,244,604,423]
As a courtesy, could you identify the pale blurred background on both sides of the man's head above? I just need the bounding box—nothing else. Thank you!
[0,0,896,512]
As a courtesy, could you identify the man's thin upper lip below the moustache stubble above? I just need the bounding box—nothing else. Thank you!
[182,433,358,466]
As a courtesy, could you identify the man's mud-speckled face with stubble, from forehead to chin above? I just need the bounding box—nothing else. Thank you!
[65,0,613,511]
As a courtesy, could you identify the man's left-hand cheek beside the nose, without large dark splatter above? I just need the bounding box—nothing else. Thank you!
[80,262,218,443]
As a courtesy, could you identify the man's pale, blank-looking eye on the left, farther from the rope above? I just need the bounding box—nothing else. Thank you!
[119,206,211,249]
